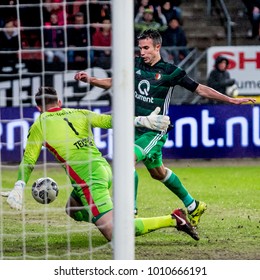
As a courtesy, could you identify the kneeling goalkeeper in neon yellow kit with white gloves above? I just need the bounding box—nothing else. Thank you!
[1,87,199,241]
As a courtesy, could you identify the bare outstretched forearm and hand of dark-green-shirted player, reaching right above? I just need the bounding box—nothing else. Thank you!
[195,84,256,105]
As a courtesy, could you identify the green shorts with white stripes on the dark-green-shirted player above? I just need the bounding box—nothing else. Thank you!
[134,131,167,169]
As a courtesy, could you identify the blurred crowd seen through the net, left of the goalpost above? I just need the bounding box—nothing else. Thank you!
[0,0,112,73]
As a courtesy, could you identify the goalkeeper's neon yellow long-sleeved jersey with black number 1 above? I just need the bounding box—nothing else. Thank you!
[18,108,112,183]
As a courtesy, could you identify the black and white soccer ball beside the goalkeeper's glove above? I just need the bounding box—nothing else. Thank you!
[32,177,59,204]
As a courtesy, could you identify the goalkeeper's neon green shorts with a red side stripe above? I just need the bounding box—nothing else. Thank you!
[71,161,113,222]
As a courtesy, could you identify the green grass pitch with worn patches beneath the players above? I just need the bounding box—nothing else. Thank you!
[0,161,260,260]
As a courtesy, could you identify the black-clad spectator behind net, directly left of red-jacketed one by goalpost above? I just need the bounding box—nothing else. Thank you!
[67,12,92,70]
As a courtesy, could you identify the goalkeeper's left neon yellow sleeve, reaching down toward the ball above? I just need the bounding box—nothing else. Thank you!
[17,122,43,183]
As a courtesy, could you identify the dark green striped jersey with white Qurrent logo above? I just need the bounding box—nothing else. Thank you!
[135,57,198,134]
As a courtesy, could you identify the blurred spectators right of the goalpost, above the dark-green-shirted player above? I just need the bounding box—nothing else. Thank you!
[134,0,188,64]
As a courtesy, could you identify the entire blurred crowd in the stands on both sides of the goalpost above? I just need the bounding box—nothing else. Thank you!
[0,0,187,73]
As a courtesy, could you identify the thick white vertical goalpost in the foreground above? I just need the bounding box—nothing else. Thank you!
[113,0,134,259]
